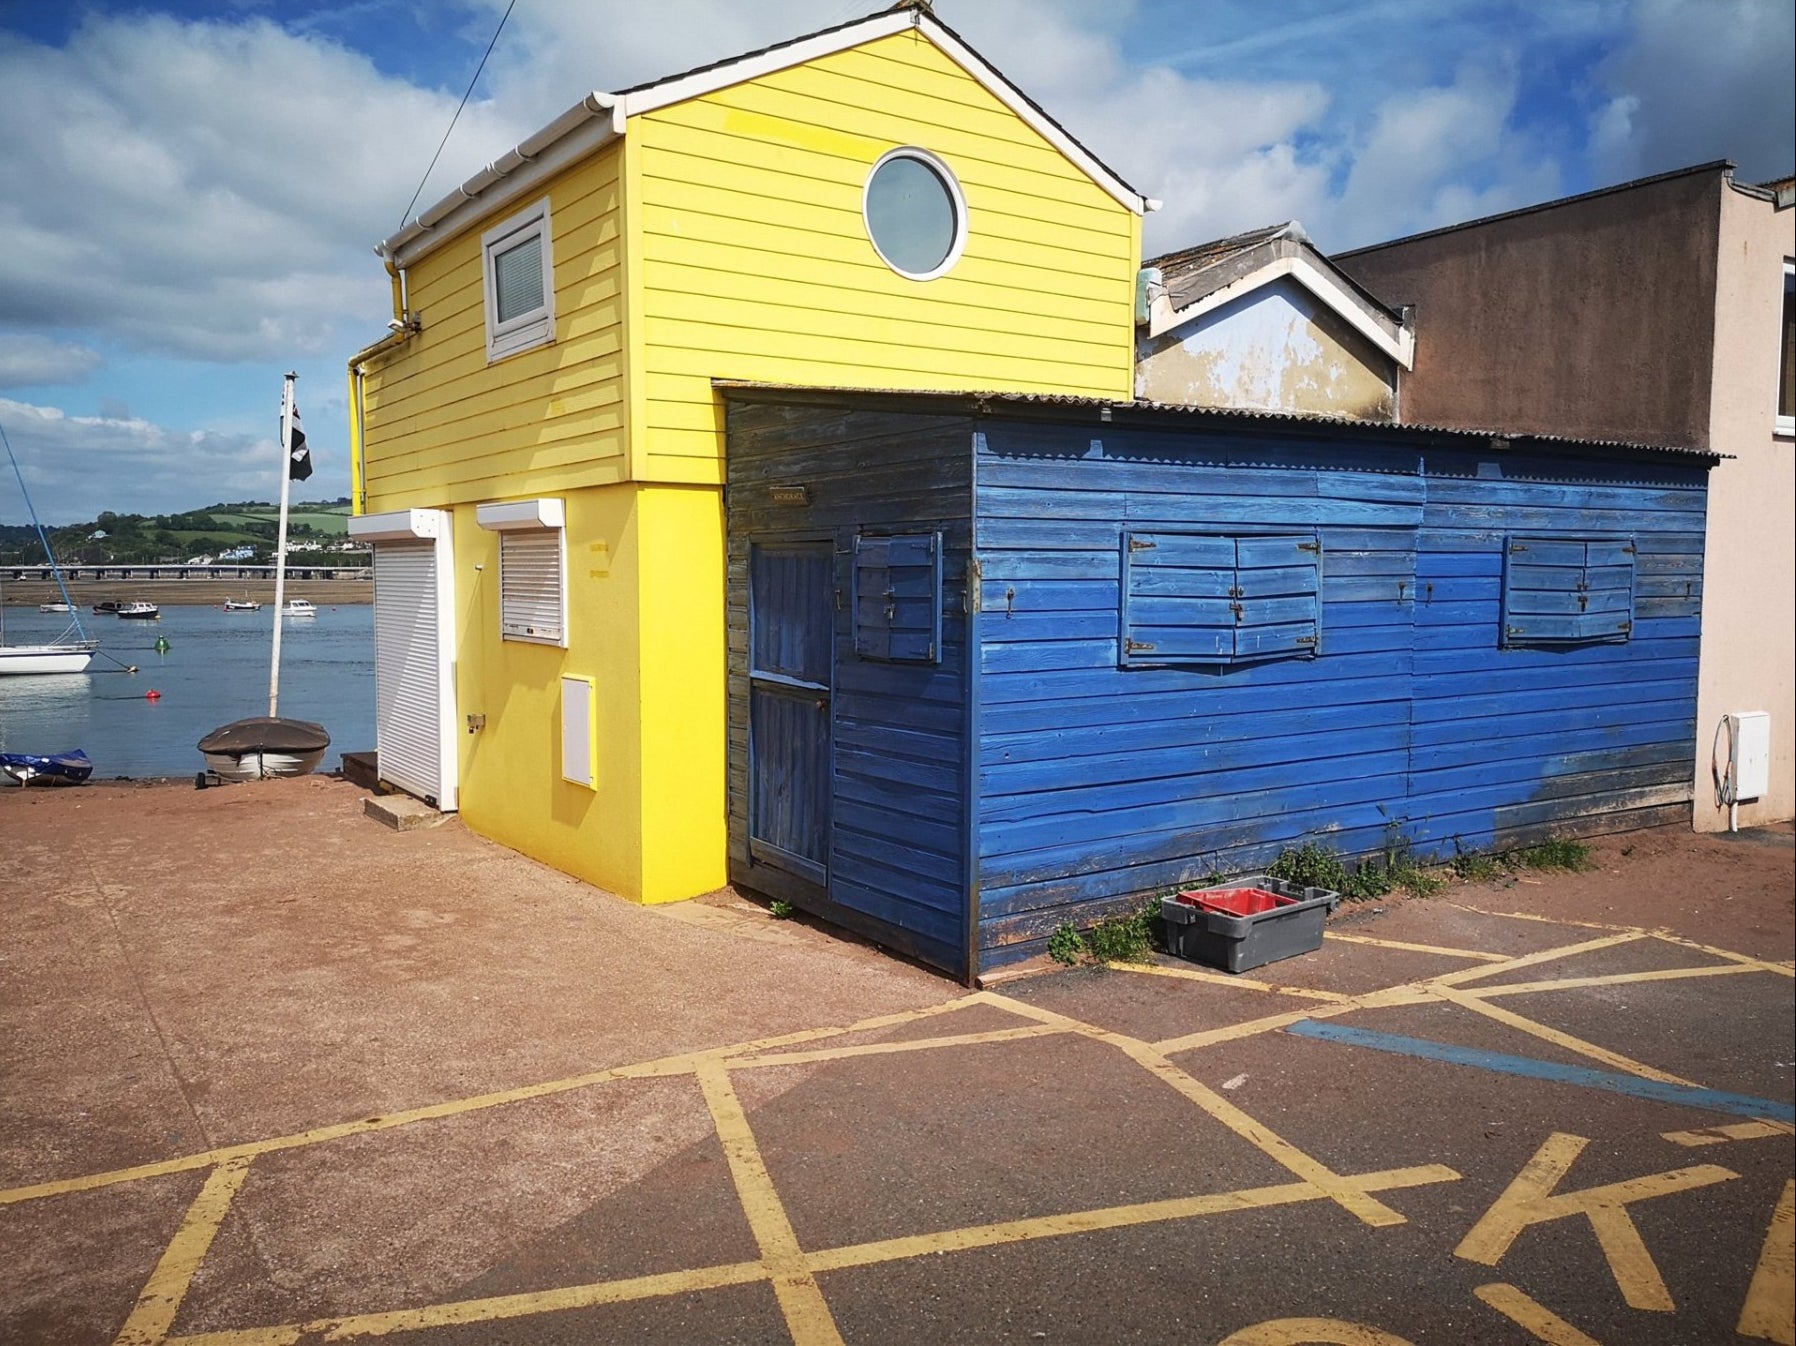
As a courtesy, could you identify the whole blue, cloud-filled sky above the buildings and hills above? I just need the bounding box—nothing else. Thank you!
[0,0,1796,521]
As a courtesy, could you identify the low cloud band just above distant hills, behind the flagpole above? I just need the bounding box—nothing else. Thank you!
[0,397,326,523]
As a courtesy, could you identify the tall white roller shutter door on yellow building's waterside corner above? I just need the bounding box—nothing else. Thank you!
[374,541,454,809]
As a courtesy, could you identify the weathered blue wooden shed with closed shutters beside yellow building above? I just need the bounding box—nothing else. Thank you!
[726,385,1715,979]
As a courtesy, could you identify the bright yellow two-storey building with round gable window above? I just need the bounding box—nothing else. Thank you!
[350,7,1155,902]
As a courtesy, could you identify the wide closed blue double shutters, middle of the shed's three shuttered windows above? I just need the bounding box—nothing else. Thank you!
[1121,532,1322,669]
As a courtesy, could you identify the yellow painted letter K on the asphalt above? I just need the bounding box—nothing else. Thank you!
[1453,1132,1739,1314]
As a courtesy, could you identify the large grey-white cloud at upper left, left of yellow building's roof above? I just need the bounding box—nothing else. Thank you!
[0,14,528,361]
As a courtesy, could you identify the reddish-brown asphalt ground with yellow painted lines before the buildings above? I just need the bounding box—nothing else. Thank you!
[0,782,1796,1346]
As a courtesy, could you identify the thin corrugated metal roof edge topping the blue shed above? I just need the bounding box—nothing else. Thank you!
[711,379,1733,460]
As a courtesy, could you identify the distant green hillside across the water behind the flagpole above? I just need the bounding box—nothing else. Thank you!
[0,496,350,564]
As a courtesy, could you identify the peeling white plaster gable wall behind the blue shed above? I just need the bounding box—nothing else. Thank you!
[1135,277,1395,421]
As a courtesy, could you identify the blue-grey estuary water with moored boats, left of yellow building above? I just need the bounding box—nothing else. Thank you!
[0,604,374,780]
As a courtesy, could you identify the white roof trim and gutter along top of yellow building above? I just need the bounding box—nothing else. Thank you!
[375,9,1160,266]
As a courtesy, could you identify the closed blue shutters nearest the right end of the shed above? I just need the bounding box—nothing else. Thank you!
[1501,537,1634,647]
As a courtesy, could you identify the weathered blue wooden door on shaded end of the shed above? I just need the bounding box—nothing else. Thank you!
[749,541,835,886]
